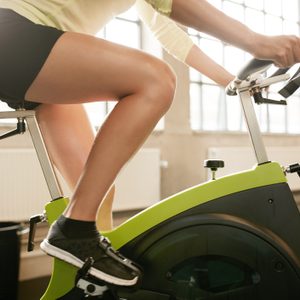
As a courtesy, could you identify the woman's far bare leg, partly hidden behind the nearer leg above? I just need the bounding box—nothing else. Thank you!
[36,104,114,230]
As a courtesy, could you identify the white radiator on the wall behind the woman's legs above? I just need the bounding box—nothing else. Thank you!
[0,149,160,221]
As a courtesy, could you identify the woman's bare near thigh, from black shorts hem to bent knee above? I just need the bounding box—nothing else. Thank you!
[25,32,170,104]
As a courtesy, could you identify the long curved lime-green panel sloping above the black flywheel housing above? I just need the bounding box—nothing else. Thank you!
[103,162,287,249]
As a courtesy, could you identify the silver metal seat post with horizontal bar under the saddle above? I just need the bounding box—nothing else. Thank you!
[0,110,63,200]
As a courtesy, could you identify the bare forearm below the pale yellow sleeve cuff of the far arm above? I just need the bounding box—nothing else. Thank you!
[185,46,234,87]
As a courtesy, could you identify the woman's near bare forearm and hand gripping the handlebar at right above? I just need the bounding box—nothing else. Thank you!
[170,0,300,67]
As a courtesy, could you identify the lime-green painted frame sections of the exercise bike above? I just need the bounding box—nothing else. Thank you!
[41,162,286,300]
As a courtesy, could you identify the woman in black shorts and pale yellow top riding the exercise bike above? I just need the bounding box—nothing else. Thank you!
[0,0,300,285]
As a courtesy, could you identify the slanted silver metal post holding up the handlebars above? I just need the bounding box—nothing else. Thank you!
[238,90,269,164]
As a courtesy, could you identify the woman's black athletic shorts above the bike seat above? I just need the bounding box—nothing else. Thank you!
[0,8,64,109]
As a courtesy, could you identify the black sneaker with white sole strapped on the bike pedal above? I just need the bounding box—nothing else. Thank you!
[41,222,141,286]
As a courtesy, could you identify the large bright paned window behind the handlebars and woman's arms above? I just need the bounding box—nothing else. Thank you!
[189,0,300,134]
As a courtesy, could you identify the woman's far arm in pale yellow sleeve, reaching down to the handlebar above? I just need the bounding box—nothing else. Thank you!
[136,0,233,87]
